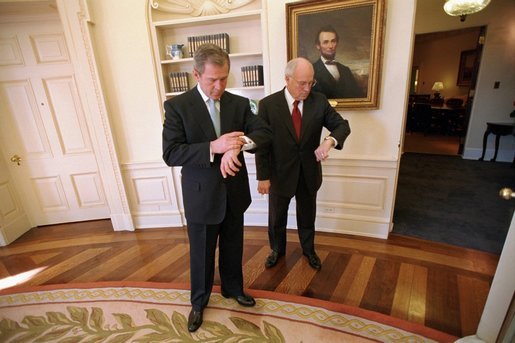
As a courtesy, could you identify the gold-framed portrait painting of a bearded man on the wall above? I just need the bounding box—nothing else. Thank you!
[286,0,386,110]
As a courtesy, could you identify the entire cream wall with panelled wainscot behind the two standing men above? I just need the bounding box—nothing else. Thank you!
[88,0,415,238]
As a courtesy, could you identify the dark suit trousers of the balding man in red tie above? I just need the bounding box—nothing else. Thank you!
[268,170,317,255]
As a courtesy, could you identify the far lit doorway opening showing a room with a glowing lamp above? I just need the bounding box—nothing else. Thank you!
[403,26,486,156]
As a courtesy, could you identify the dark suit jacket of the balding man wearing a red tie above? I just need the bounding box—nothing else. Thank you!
[256,89,350,197]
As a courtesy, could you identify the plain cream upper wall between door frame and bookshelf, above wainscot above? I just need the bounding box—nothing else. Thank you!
[88,0,162,164]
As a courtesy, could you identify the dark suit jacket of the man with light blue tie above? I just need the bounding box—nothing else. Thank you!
[163,87,271,225]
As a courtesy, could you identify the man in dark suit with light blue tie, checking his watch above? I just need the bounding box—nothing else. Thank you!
[163,44,271,332]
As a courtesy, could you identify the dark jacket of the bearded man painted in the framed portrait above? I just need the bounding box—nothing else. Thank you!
[313,59,366,99]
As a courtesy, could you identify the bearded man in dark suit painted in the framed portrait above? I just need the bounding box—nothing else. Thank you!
[313,26,365,99]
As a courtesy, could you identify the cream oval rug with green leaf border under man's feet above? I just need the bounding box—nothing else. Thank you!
[0,282,457,343]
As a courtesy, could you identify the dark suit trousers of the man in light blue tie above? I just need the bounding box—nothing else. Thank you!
[188,207,243,311]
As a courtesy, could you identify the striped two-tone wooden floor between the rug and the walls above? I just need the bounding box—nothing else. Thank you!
[0,220,498,336]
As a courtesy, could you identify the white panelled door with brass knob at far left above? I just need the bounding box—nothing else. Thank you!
[0,18,109,225]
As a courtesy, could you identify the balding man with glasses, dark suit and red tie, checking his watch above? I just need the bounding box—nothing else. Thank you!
[256,58,350,270]
